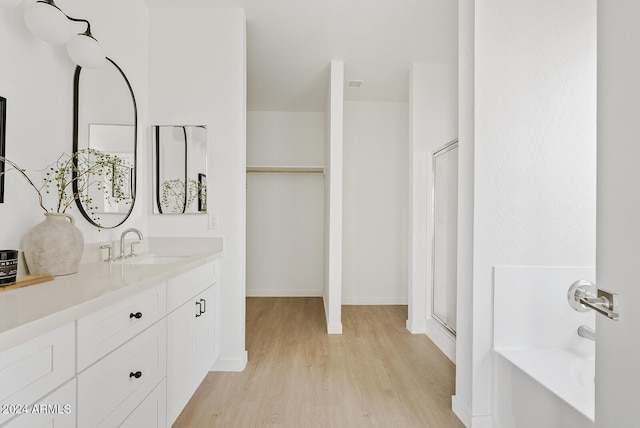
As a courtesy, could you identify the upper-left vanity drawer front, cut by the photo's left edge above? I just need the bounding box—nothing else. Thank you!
[0,323,75,424]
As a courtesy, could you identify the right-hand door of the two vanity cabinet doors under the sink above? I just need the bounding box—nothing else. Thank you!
[193,287,216,382]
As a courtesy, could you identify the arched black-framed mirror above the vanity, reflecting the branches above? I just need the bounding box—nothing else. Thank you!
[73,58,138,229]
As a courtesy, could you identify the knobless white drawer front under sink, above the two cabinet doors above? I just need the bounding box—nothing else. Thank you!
[167,261,218,312]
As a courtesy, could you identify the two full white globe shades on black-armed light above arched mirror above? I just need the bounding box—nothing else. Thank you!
[21,0,106,68]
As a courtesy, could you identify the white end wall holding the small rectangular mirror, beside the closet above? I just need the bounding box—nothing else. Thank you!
[145,7,247,370]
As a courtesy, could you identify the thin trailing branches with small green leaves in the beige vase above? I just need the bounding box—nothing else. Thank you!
[0,149,129,220]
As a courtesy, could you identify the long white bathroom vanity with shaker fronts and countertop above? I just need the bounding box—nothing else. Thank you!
[0,238,223,428]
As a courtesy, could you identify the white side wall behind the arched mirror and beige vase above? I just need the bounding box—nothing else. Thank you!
[0,0,148,248]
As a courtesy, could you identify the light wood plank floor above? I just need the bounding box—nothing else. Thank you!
[174,298,463,428]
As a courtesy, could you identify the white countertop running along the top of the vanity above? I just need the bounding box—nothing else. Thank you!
[0,238,223,352]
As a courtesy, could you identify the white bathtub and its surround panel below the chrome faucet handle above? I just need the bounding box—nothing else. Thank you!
[494,266,595,428]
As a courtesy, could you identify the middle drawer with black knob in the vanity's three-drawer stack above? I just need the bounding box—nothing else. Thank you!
[78,319,167,427]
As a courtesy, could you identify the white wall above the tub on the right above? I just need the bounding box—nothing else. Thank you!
[454,0,596,427]
